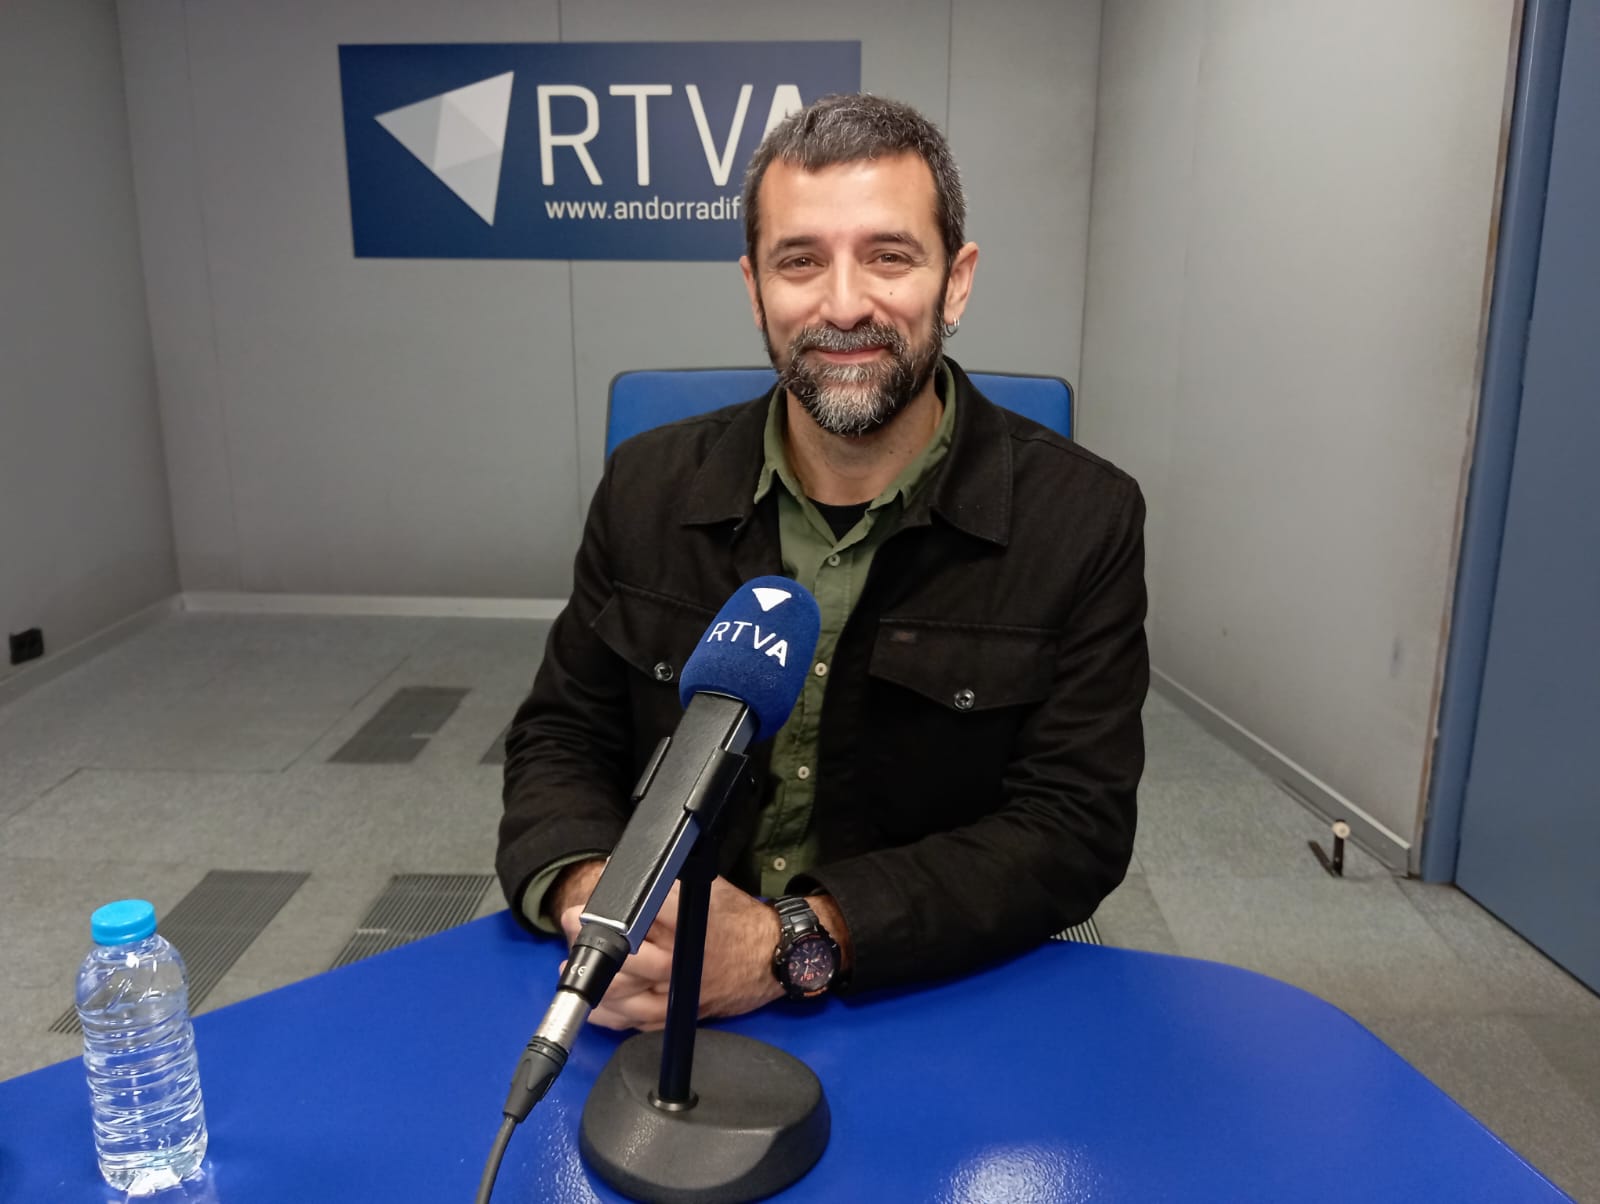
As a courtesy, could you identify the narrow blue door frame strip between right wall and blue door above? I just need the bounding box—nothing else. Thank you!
[1418,0,1571,882]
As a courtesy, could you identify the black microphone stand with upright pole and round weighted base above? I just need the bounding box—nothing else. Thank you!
[579,774,830,1204]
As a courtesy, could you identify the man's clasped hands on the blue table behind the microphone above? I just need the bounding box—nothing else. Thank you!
[560,877,782,1033]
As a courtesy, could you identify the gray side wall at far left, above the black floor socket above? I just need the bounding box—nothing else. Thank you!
[0,0,176,676]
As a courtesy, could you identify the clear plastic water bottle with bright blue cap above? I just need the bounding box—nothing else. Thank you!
[77,898,206,1194]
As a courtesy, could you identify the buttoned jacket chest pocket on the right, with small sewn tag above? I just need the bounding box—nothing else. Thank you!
[864,621,1056,839]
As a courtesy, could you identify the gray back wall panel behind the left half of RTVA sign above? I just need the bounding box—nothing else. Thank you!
[123,0,578,596]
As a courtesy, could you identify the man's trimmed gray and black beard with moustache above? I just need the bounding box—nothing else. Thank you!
[762,322,944,437]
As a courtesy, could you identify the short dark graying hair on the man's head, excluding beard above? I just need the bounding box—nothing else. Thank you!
[744,93,966,272]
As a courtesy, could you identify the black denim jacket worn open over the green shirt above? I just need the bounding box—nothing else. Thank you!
[496,360,1149,991]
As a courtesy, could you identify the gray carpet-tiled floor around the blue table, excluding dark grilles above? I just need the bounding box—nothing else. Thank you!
[0,615,1600,1204]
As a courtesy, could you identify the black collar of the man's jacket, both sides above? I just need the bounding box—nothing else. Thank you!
[680,357,1011,548]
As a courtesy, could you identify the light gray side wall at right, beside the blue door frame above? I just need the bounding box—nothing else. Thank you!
[1083,0,1515,839]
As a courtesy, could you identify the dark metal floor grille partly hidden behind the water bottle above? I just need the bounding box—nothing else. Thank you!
[50,869,309,1033]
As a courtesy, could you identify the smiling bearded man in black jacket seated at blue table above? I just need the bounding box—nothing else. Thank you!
[498,96,1149,1029]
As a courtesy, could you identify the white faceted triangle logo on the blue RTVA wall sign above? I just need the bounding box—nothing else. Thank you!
[374,70,514,226]
